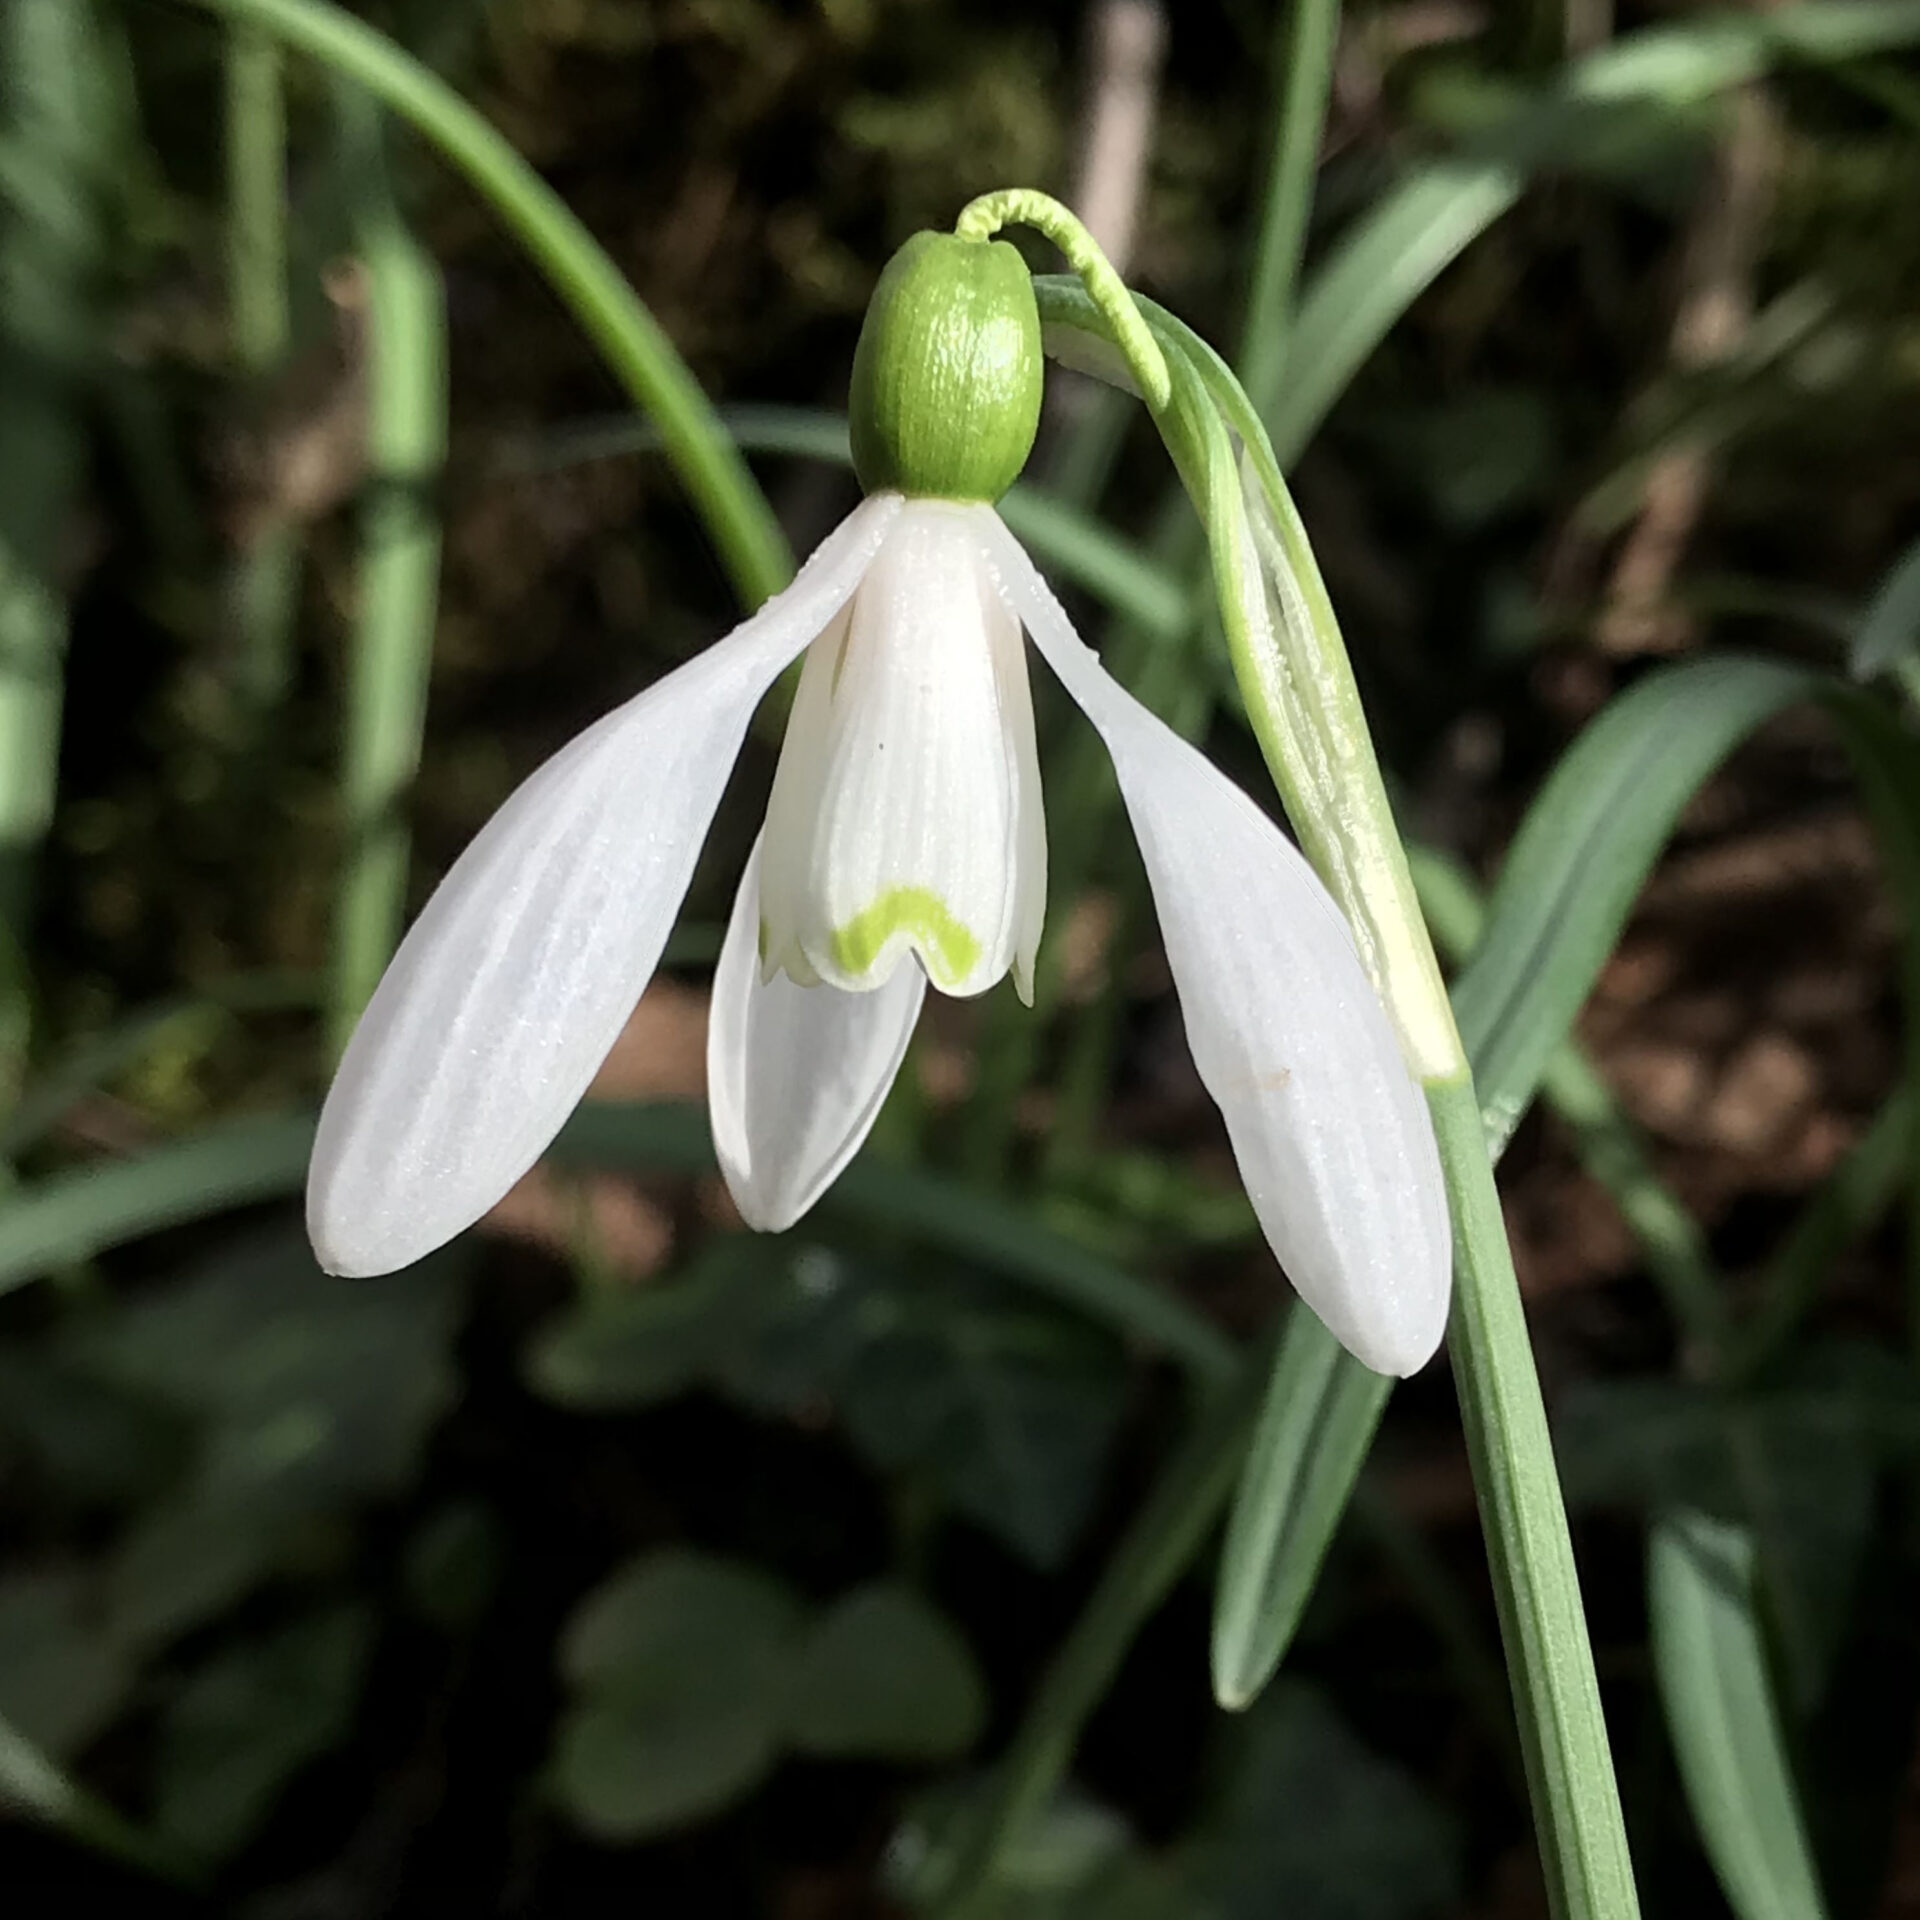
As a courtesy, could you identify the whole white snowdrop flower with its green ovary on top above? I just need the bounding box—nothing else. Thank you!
[307,234,1450,1373]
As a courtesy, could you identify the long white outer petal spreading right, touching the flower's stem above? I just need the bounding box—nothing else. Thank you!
[995,510,1452,1373]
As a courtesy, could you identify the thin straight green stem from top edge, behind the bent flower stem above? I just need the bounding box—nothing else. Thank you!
[1240,0,1340,413]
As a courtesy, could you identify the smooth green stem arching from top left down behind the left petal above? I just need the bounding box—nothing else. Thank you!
[192,0,793,605]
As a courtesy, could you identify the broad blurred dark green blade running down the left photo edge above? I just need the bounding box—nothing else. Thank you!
[0,0,111,1104]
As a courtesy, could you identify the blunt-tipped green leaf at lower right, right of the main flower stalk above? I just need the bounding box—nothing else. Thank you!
[1647,1509,1826,1920]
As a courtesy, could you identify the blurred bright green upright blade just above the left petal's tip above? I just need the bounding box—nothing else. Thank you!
[328,81,447,1054]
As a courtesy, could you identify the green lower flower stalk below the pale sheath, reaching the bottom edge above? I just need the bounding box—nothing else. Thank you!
[1427,1073,1640,1920]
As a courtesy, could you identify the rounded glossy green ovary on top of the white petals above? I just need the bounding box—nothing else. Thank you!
[849,232,1041,501]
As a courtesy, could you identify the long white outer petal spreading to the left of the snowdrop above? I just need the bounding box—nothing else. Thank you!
[307,495,900,1275]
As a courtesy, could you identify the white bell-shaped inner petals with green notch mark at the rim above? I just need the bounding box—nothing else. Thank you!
[760,501,1046,995]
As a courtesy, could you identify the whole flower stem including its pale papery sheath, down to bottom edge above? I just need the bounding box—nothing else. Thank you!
[1035,266,1638,1920]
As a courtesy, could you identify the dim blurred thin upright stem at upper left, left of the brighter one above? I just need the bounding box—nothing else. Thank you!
[225,27,301,722]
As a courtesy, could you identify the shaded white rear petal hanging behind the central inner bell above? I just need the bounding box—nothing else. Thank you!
[707,847,927,1233]
